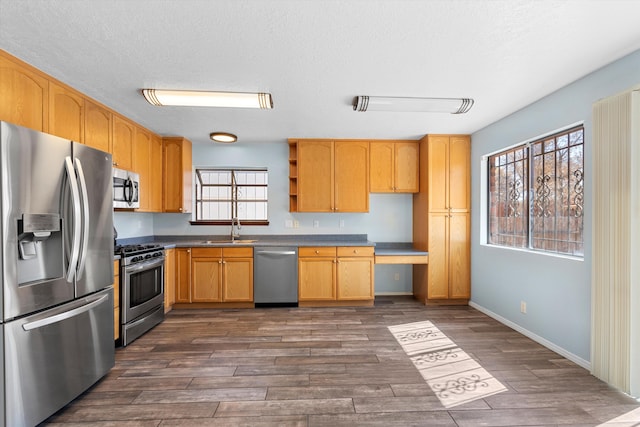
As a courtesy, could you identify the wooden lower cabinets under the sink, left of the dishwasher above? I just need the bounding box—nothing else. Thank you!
[175,247,253,305]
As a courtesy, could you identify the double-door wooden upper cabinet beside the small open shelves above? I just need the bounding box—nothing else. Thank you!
[297,140,369,212]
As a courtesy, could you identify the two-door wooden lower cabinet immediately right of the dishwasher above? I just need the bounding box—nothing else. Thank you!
[298,246,374,305]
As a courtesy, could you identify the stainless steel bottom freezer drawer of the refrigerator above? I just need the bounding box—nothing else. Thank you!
[2,288,115,427]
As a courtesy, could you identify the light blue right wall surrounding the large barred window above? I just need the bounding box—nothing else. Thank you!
[471,51,640,366]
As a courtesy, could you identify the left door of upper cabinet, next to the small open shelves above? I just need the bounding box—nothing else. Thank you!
[298,140,334,212]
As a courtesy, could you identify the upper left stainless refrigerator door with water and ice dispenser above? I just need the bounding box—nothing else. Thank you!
[0,122,74,321]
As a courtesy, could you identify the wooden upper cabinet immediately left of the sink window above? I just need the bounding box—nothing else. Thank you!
[162,137,193,213]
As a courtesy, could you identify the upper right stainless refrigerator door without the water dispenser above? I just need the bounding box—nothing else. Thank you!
[72,142,113,297]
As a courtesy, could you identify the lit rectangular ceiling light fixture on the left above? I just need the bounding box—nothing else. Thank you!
[142,89,273,110]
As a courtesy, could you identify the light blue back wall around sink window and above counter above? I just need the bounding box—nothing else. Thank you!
[114,141,413,293]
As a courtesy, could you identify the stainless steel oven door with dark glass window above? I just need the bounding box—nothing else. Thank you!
[121,257,164,324]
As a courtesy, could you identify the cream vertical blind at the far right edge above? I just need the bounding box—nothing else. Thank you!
[591,90,640,397]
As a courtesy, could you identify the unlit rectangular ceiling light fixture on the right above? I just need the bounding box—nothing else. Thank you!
[353,96,473,114]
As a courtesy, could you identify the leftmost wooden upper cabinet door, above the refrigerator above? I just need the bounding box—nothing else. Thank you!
[0,51,49,132]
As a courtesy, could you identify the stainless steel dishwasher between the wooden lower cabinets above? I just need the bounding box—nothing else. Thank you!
[253,246,298,307]
